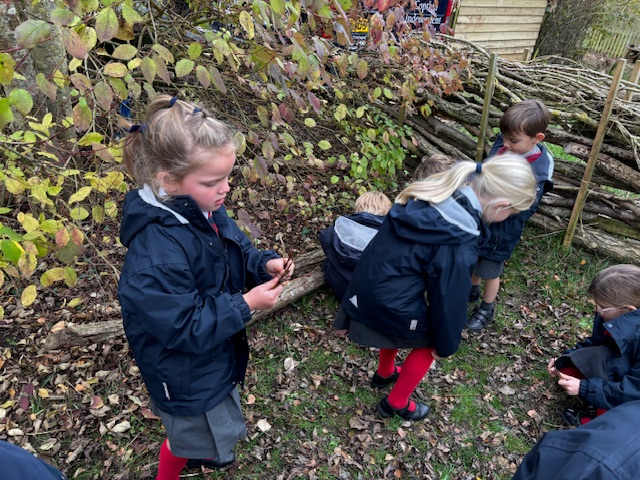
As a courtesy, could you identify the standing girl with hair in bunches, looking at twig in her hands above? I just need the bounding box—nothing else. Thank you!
[118,95,294,480]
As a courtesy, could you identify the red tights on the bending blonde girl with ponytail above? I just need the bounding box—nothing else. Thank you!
[378,348,433,411]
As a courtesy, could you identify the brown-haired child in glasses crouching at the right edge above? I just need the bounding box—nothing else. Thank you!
[547,265,640,426]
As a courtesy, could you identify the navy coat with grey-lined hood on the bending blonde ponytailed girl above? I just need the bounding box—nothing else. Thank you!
[342,187,486,357]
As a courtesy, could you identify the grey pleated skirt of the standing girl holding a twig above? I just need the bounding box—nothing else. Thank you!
[151,387,247,462]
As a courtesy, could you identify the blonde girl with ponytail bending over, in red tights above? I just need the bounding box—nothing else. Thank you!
[334,154,536,420]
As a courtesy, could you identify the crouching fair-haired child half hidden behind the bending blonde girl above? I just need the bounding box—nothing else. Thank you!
[320,191,391,300]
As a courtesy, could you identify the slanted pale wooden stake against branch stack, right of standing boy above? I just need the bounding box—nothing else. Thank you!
[562,59,627,250]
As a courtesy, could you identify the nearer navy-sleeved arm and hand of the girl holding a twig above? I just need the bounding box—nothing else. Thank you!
[118,231,282,354]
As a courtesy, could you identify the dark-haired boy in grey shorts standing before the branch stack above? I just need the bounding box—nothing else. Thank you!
[467,100,553,332]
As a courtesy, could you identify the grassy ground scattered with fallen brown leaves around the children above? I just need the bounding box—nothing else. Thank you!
[0,199,605,480]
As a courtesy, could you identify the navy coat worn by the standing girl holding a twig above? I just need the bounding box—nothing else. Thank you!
[118,186,278,416]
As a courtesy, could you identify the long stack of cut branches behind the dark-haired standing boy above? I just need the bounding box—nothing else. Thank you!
[386,37,640,263]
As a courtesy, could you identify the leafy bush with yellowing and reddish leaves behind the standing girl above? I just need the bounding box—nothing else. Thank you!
[0,0,467,313]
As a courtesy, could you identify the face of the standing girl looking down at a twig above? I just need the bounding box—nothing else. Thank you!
[163,148,236,212]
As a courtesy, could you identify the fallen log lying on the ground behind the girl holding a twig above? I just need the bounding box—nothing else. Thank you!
[40,249,325,353]
